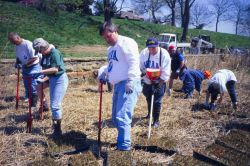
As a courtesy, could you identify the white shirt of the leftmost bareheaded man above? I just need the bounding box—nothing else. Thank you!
[15,39,39,65]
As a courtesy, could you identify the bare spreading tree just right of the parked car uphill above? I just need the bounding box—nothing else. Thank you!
[134,0,164,23]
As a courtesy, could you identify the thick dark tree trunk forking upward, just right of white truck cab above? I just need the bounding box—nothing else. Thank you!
[177,0,195,42]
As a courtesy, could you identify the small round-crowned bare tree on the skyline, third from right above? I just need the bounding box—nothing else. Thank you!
[190,3,212,29]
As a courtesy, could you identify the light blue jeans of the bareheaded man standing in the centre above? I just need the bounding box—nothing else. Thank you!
[112,80,142,150]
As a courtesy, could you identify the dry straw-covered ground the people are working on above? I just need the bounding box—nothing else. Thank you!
[0,55,250,165]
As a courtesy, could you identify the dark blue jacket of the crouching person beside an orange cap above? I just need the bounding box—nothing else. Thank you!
[180,69,205,93]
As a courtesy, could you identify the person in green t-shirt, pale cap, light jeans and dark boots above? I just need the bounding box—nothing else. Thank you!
[33,38,68,137]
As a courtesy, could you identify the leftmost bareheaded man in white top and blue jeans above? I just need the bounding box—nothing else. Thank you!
[8,32,41,109]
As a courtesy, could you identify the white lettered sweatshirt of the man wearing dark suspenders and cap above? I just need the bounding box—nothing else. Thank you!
[140,47,171,84]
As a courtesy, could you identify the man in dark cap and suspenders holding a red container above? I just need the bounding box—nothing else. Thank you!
[140,38,171,127]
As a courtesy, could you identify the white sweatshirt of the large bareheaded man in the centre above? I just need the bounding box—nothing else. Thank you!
[108,35,141,84]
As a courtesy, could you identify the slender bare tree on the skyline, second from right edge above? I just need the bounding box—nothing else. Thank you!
[211,0,232,32]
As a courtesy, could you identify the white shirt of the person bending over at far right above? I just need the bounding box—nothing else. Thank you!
[208,69,237,93]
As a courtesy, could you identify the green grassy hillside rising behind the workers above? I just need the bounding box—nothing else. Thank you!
[0,1,250,58]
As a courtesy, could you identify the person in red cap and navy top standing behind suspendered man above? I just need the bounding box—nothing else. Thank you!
[168,45,186,96]
